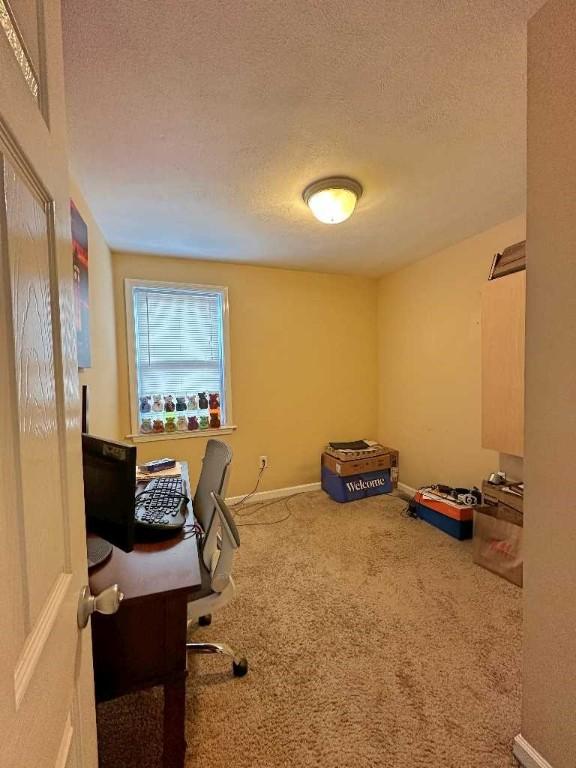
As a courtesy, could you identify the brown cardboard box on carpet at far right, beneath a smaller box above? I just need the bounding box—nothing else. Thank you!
[472,505,523,587]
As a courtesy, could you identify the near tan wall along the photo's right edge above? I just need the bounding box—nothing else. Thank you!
[522,0,576,768]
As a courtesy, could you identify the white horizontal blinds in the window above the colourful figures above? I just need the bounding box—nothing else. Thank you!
[132,285,226,423]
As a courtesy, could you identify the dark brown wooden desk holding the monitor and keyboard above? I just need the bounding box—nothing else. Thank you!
[90,465,202,768]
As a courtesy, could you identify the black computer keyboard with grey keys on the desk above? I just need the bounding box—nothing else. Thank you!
[135,477,188,531]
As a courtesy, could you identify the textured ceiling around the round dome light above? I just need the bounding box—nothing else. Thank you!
[63,0,542,274]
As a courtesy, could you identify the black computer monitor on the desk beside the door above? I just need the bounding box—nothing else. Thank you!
[82,435,136,552]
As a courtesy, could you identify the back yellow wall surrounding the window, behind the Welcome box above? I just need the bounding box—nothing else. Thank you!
[113,254,377,495]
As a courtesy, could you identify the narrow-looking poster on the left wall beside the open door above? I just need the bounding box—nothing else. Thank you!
[70,200,90,368]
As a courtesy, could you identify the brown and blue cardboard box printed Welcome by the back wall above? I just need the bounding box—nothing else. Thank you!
[321,446,398,503]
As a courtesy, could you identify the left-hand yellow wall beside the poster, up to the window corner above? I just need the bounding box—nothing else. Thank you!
[70,178,120,438]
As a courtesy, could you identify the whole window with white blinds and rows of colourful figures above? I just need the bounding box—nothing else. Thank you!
[126,280,231,438]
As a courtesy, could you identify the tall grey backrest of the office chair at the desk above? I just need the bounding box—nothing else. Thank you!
[192,439,232,569]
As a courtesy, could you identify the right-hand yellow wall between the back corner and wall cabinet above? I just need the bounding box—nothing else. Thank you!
[378,217,525,487]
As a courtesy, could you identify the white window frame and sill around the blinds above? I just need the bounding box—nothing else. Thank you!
[124,278,236,442]
